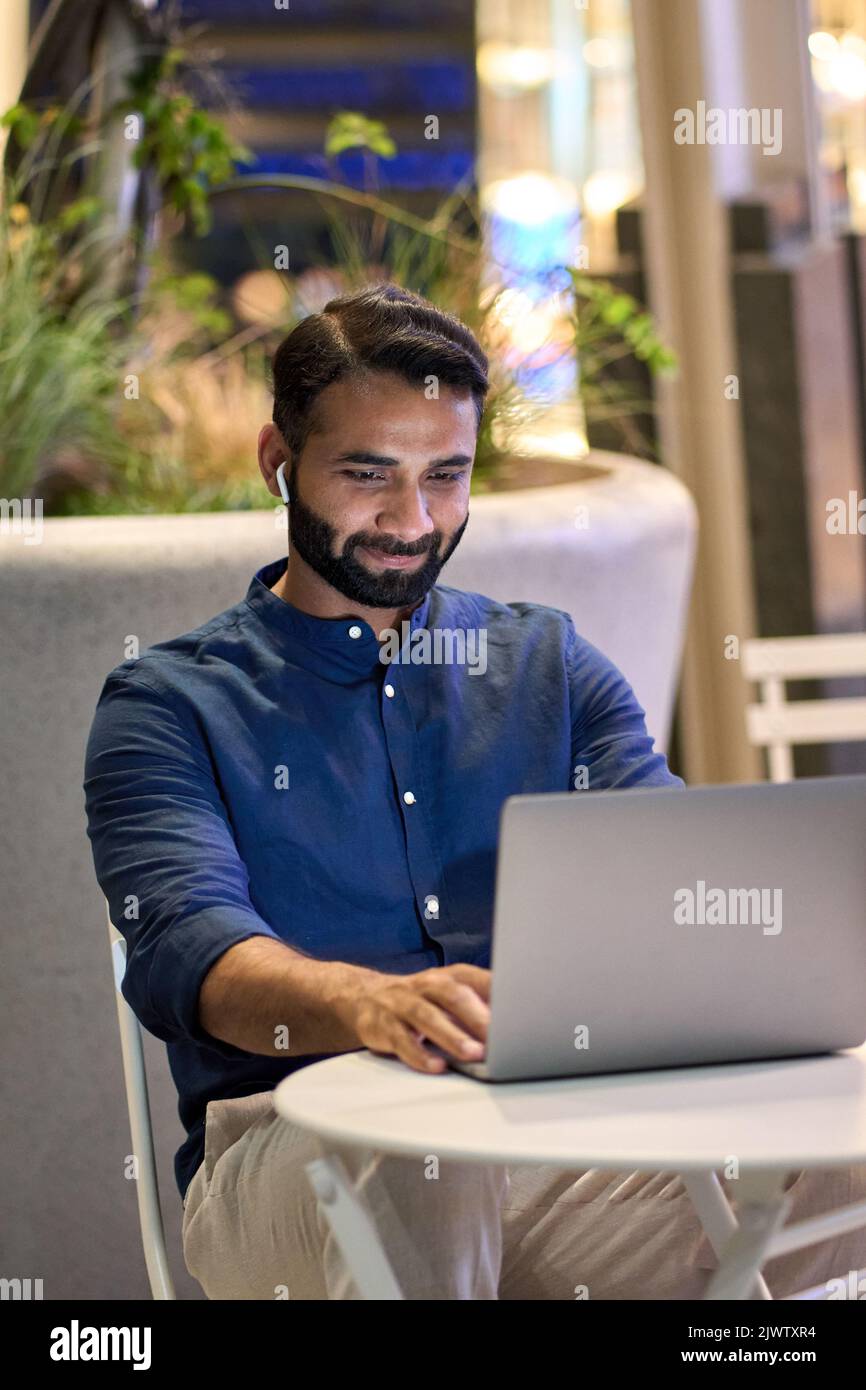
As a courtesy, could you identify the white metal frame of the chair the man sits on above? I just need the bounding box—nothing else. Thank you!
[106,904,177,1300]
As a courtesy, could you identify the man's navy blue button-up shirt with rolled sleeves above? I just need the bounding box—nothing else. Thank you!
[83,559,683,1195]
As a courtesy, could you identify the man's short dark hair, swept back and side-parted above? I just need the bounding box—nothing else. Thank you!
[271,285,488,459]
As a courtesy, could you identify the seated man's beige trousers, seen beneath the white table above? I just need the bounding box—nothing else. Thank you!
[183,1091,866,1300]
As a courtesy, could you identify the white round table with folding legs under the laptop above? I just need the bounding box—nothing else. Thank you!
[274,1044,866,1298]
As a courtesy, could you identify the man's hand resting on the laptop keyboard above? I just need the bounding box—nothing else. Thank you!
[345,965,491,1072]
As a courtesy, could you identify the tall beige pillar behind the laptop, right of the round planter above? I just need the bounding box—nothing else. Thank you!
[632,0,760,783]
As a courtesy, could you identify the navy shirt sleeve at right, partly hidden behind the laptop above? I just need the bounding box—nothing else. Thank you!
[566,617,685,791]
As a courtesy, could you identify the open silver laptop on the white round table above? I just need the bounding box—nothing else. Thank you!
[450,776,866,1081]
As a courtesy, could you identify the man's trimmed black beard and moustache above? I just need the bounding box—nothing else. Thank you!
[289,470,468,609]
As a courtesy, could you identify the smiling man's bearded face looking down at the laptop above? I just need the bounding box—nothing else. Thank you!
[289,371,477,609]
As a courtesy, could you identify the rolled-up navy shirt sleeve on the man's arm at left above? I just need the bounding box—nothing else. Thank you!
[83,671,281,1058]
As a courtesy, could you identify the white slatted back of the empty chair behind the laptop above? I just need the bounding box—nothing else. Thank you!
[742,632,866,783]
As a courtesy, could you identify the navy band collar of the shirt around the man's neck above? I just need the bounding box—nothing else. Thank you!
[246,556,432,676]
